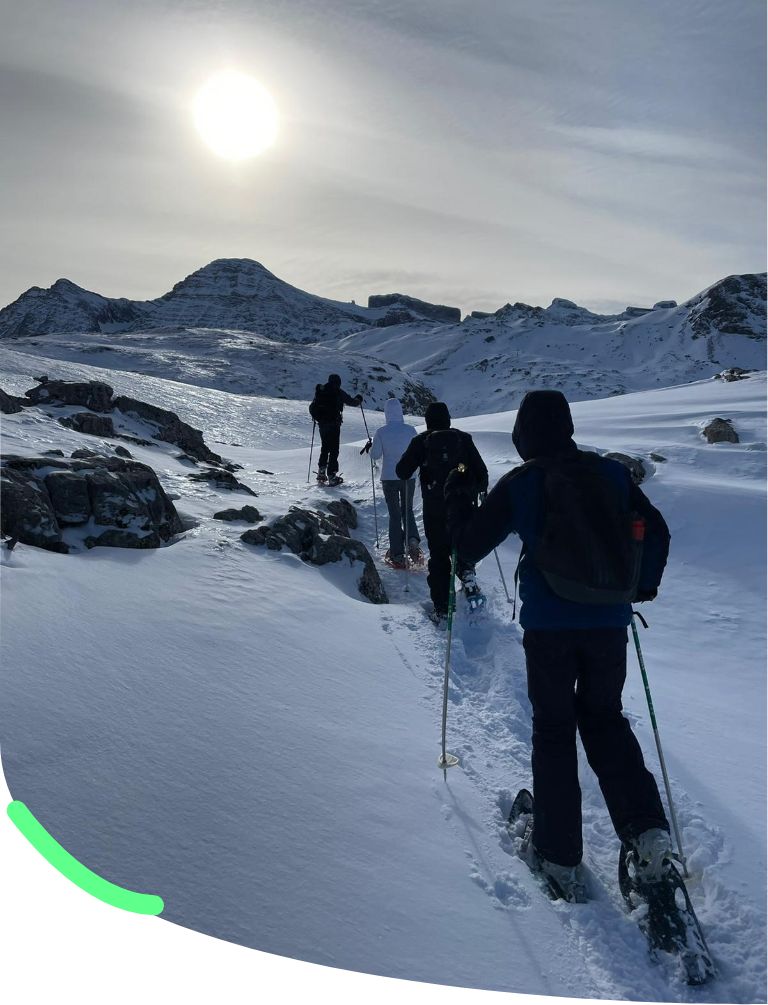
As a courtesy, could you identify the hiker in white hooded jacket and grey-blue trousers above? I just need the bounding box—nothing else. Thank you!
[366,398,423,569]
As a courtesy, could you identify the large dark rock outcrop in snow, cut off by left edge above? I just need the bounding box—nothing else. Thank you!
[0,451,183,553]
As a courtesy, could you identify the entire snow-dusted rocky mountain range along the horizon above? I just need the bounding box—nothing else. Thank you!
[0,259,766,415]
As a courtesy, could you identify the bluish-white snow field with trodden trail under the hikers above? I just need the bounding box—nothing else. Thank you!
[0,343,766,1002]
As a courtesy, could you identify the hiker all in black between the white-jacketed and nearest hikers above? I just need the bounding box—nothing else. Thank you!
[395,401,488,623]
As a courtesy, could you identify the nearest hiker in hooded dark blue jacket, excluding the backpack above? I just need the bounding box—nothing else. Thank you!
[445,391,670,899]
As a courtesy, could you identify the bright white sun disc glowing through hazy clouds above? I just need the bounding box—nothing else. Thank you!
[192,69,277,161]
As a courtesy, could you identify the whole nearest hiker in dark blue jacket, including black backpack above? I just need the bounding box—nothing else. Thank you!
[445,391,671,901]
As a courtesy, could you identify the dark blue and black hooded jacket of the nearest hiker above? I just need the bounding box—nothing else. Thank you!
[446,391,669,630]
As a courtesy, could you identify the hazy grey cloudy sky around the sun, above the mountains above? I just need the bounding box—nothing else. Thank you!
[0,0,766,311]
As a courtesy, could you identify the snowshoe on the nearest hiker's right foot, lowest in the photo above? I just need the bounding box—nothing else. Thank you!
[618,843,717,985]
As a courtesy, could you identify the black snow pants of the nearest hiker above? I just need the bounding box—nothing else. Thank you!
[523,628,669,865]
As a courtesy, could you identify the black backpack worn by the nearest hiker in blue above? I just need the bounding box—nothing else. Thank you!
[519,450,645,604]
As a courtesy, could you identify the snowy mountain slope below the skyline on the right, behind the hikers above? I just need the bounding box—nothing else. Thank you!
[339,274,766,415]
